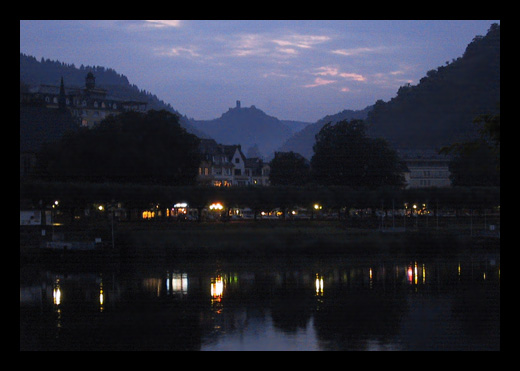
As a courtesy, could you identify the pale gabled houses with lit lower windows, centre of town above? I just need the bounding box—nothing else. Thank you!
[197,139,269,187]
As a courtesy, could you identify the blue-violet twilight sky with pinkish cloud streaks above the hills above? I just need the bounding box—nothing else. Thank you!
[20,20,500,122]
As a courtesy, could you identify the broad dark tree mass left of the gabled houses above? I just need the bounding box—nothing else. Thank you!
[33,110,200,185]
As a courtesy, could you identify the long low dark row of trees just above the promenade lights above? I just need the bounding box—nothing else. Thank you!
[20,181,500,217]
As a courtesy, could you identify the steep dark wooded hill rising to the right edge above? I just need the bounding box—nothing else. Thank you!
[367,24,500,149]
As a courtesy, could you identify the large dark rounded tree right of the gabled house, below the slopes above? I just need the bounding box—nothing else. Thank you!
[311,120,404,188]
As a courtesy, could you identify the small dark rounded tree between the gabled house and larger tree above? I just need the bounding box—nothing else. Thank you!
[269,151,310,185]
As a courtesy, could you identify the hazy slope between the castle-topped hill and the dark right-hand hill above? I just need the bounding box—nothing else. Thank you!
[278,106,372,160]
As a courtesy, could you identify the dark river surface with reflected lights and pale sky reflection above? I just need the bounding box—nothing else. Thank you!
[20,252,500,350]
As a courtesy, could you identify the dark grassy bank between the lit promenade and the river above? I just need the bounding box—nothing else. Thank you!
[112,221,497,256]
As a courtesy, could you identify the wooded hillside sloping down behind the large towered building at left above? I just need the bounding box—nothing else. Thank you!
[20,53,208,138]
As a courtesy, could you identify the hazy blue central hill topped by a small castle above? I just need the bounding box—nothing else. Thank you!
[191,105,293,158]
